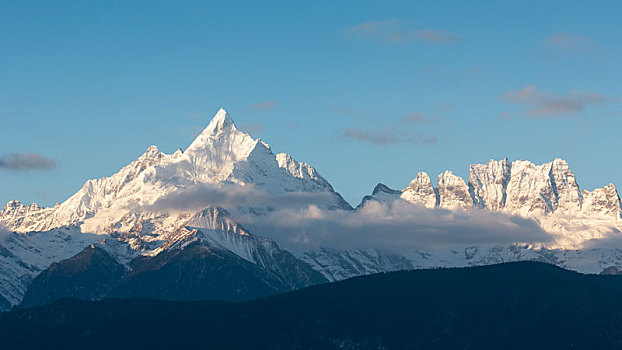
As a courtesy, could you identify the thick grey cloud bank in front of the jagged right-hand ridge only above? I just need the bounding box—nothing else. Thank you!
[237,201,552,254]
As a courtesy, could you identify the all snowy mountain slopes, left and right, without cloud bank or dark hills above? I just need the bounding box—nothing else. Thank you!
[0,109,622,305]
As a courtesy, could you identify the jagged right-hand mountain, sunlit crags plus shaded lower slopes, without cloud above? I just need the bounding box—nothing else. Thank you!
[302,159,622,280]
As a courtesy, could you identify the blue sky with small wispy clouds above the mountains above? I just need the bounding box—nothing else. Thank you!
[0,1,622,205]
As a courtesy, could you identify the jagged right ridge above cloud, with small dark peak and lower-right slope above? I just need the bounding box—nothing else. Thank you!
[364,158,622,249]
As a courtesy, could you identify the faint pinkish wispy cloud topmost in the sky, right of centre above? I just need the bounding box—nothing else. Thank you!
[344,19,460,44]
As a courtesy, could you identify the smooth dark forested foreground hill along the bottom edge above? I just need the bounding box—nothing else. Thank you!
[0,262,622,349]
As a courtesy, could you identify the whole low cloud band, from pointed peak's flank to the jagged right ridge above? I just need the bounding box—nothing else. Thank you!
[144,185,552,253]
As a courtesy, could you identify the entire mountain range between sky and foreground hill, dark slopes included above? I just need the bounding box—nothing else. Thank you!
[0,109,622,310]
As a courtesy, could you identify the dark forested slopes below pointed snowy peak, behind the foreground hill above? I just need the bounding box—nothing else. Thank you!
[20,244,327,309]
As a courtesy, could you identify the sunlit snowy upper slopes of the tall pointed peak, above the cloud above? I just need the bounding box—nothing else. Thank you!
[0,109,347,233]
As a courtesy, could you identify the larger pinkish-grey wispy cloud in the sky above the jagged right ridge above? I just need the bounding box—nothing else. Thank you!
[501,85,607,118]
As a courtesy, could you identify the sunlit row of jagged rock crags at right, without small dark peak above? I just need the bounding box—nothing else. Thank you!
[378,158,622,221]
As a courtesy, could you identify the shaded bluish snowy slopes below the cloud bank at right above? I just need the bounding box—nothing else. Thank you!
[308,244,622,281]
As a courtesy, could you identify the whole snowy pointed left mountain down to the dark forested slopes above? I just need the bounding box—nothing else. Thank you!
[0,109,344,305]
